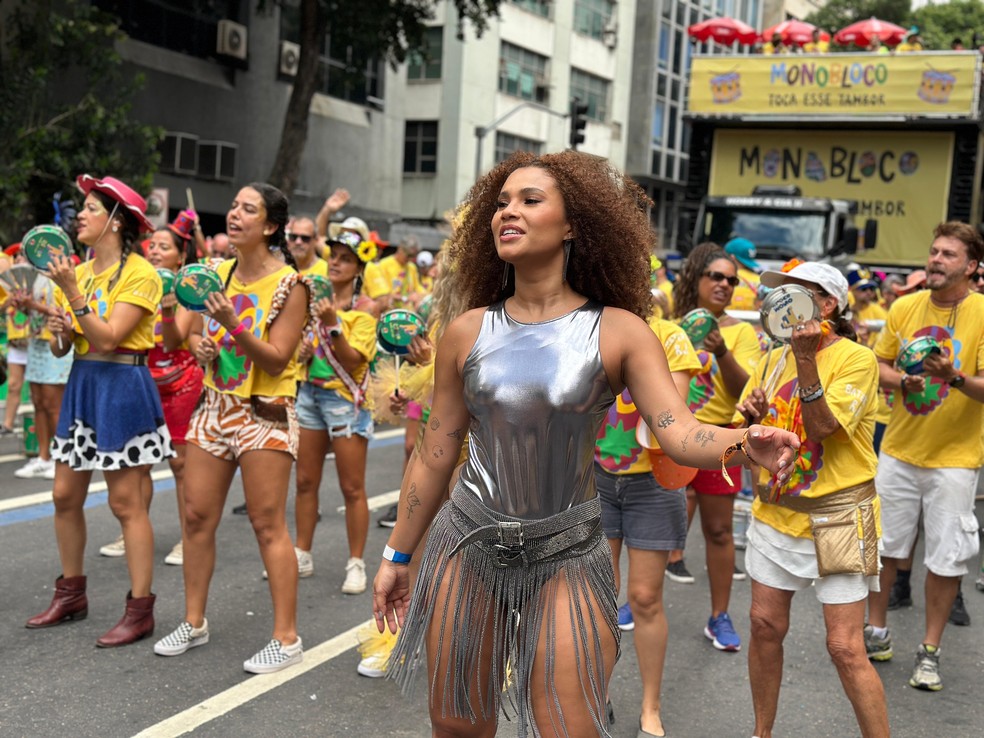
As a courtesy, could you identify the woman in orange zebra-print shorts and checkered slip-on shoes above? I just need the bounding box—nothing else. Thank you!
[154,182,308,674]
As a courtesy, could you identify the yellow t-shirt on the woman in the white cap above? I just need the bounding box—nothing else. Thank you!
[735,338,879,538]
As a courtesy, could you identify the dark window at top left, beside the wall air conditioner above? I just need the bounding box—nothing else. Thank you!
[92,0,245,59]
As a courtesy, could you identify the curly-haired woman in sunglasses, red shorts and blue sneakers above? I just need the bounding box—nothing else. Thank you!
[666,243,762,651]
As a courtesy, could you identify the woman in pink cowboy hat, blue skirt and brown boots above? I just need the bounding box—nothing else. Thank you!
[27,174,174,648]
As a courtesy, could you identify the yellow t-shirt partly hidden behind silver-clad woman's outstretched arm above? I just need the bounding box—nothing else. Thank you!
[595,317,701,474]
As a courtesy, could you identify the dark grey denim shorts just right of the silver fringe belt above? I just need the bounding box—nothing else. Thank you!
[595,464,687,551]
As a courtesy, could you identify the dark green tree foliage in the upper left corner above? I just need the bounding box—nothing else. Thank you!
[0,0,163,243]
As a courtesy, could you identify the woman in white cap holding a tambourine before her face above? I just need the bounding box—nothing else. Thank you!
[735,262,888,736]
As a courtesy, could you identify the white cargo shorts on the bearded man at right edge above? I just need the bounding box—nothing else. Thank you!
[875,452,980,577]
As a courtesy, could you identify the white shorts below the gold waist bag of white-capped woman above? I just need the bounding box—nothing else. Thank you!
[745,518,878,605]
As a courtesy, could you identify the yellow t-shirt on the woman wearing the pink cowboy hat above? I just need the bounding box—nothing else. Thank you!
[55,254,164,354]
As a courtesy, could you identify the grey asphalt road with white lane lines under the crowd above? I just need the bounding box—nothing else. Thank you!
[0,426,984,738]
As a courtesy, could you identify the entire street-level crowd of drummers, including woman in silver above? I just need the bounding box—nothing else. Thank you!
[4,151,984,738]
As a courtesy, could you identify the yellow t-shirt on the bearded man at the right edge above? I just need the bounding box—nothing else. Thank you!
[875,290,984,469]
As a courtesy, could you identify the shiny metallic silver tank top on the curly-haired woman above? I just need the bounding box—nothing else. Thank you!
[458,301,615,520]
